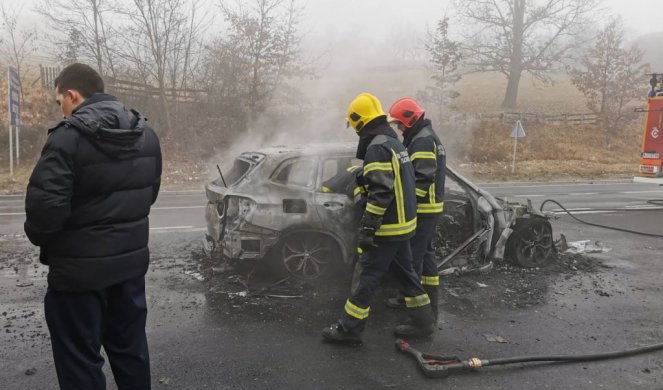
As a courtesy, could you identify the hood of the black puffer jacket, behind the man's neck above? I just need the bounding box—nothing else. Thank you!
[62,93,147,159]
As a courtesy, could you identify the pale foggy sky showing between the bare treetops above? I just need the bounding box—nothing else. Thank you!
[15,0,663,63]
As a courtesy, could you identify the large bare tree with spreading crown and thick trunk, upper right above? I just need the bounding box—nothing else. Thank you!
[456,0,602,108]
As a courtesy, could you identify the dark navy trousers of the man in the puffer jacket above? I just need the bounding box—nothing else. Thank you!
[44,276,150,390]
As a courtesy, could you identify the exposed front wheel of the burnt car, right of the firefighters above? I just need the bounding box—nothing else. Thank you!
[507,218,555,268]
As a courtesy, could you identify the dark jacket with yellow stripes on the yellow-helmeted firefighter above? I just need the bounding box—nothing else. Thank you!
[357,118,417,241]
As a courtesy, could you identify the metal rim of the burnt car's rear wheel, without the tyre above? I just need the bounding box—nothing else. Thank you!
[281,234,331,279]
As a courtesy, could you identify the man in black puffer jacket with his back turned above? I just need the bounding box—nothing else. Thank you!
[25,64,161,389]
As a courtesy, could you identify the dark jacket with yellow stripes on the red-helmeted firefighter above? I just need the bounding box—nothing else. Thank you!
[403,118,447,215]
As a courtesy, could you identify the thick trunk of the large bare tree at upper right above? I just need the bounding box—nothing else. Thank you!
[502,0,525,108]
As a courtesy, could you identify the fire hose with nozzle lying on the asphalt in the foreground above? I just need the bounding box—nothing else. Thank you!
[396,339,663,378]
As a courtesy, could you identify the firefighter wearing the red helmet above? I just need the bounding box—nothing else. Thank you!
[387,98,446,320]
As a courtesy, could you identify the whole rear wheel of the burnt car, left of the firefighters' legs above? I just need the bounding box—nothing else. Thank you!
[274,232,341,280]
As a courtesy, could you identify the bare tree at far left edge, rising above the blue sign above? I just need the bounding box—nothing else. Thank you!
[0,4,37,100]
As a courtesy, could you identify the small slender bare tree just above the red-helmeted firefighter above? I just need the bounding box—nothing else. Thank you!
[418,17,462,121]
